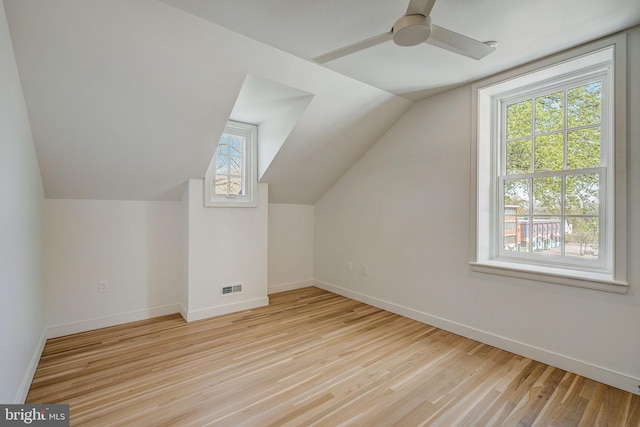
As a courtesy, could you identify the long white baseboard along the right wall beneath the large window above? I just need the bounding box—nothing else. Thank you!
[314,280,640,394]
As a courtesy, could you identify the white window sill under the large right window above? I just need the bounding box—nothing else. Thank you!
[469,260,629,294]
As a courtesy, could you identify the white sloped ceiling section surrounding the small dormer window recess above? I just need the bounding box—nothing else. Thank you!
[4,0,411,203]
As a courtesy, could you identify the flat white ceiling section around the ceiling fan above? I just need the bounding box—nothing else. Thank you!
[161,0,640,100]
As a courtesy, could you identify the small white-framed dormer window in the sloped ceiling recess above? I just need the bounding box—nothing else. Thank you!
[205,121,257,207]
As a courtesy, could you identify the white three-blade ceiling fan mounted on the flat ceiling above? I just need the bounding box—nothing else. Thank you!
[313,0,497,64]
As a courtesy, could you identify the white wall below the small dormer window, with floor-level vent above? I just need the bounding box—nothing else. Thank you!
[182,179,269,321]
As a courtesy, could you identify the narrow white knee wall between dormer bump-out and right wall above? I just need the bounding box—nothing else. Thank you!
[269,203,314,294]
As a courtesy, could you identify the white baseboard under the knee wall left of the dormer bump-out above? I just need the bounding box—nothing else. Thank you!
[47,304,180,338]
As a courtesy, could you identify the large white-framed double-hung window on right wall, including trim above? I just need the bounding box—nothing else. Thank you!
[471,39,627,292]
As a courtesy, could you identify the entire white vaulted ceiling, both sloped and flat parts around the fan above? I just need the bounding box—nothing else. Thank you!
[4,0,640,203]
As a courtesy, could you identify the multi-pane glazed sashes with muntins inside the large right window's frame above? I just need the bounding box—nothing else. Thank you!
[497,73,611,270]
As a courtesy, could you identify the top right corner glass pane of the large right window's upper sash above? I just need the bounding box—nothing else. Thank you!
[567,82,602,128]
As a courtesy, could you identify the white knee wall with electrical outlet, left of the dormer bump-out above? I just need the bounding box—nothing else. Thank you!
[44,199,183,336]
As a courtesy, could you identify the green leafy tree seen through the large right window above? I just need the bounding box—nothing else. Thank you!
[503,81,602,255]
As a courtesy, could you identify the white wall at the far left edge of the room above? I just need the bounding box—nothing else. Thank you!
[0,6,44,403]
